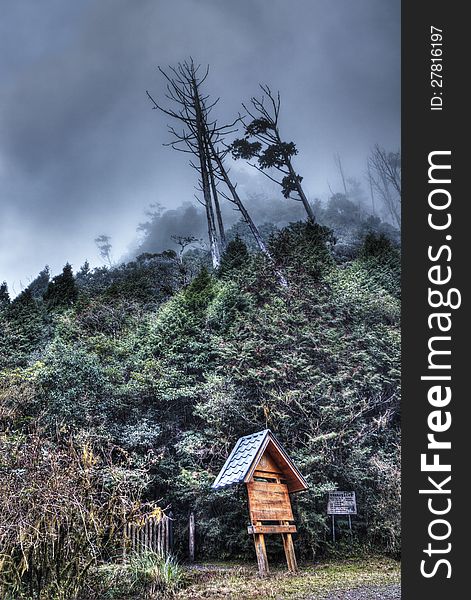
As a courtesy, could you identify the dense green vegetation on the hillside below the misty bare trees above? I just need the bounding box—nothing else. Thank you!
[0,218,400,592]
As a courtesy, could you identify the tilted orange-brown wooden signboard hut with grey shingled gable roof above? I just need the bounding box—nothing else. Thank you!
[212,429,307,576]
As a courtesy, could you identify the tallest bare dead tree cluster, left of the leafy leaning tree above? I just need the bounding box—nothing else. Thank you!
[147,60,286,284]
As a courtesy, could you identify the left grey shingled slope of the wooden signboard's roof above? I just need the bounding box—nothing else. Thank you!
[211,429,270,489]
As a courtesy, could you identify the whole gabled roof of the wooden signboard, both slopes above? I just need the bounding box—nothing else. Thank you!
[211,429,307,492]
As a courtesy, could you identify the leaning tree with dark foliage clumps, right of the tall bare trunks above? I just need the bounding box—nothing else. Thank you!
[231,85,316,223]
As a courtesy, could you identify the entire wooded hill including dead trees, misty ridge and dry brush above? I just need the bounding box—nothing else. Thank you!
[0,59,400,600]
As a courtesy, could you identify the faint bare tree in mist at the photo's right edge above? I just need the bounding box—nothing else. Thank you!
[368,144,401,228]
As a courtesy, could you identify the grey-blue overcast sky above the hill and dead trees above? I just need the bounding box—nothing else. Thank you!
[0,0,400,292]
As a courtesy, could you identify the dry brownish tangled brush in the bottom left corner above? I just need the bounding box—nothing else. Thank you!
[0,432,147,600]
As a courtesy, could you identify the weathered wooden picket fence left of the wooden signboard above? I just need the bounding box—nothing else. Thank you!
[123,513,173,556]
